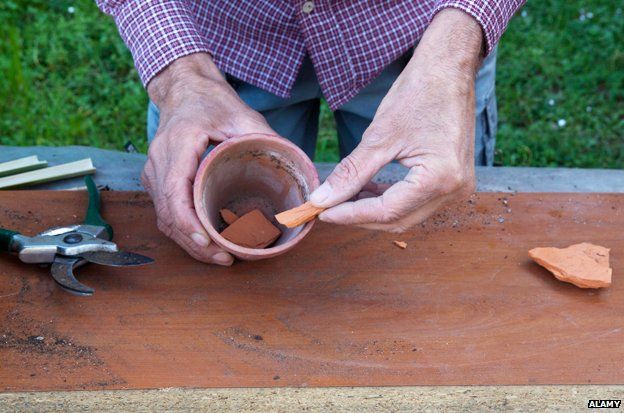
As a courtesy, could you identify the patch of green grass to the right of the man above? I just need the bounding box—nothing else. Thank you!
[497,0,624,168]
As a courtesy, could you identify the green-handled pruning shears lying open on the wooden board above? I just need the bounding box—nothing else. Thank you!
[0,176,154,296]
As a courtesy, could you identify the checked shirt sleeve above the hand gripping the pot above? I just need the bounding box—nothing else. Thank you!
[96,0,209,86]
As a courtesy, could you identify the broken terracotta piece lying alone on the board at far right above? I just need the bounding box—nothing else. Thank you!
[529,242,612,288]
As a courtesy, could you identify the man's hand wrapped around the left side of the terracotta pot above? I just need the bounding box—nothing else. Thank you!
[141,53,275,265]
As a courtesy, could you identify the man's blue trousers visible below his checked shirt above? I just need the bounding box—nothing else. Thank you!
[147,50,497,165]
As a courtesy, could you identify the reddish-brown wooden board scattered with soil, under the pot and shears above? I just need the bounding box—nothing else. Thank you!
[0,191,624,391]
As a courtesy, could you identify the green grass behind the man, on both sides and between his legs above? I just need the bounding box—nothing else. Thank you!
[0,0,624,168]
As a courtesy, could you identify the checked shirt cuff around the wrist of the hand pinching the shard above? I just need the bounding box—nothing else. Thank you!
[432,0,526,54]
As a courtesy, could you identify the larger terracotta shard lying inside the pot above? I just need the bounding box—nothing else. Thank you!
[221,209,282,248]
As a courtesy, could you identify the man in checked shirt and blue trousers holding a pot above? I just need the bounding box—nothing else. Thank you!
[98,0,523,265]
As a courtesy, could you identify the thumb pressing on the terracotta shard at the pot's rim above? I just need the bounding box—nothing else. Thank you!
[310,141,389,208]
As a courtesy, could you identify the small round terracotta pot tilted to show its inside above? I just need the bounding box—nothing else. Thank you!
[193,134,319,260]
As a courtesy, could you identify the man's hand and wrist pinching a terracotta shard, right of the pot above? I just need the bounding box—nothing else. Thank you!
[310,9,483,232]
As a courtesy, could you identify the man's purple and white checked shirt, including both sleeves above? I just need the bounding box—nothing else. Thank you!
[97,0,524,109]
